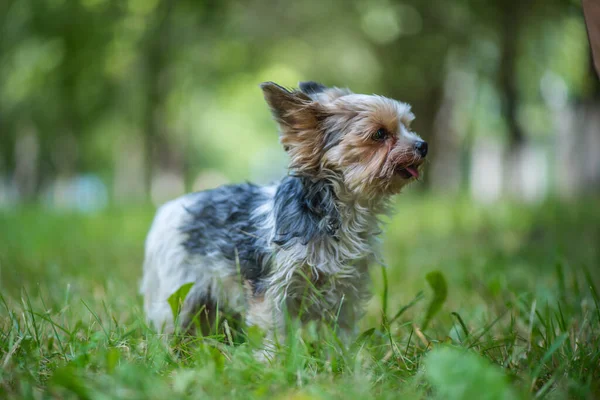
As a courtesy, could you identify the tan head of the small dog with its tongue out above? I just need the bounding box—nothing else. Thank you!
[261,82,427,199]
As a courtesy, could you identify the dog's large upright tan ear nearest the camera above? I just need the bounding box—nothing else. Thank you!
[260,82,326,174]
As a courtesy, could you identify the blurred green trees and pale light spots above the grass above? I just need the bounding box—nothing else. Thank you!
[0,0,600,206]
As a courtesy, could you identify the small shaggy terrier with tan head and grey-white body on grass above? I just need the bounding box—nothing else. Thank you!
[141,82,427,344]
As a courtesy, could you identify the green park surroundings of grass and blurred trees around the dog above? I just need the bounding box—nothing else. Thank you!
[0,0,600,399]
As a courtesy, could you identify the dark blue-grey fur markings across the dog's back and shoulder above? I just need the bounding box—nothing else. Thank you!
[180,176,340,293]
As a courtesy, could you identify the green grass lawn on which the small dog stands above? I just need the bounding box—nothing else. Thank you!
[0,196,600,399]
